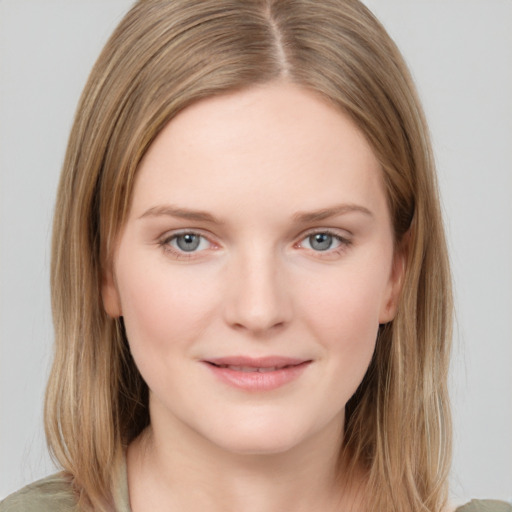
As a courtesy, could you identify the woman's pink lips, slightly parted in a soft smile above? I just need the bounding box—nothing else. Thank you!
[201,356,312,392]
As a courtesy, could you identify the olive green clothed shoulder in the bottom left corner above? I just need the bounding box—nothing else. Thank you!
[0,473,76,512]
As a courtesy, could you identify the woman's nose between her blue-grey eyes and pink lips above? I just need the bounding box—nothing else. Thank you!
[225,251,292,335]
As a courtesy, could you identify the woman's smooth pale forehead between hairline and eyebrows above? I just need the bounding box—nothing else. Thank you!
[133,83,383,221]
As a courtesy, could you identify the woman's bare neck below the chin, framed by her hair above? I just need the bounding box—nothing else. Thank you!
[127,406,364,512]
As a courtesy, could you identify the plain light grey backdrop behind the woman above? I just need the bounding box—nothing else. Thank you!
[0,0,512,502]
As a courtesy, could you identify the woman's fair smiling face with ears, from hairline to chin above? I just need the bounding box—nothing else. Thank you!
[103,83,402,453]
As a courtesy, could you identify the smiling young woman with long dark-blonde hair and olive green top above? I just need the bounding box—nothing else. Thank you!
[0,0,509,512]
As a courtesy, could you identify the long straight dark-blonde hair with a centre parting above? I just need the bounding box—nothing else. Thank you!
[45,0,452,512]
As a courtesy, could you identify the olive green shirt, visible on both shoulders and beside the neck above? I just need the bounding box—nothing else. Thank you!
[0,468,512,512]
